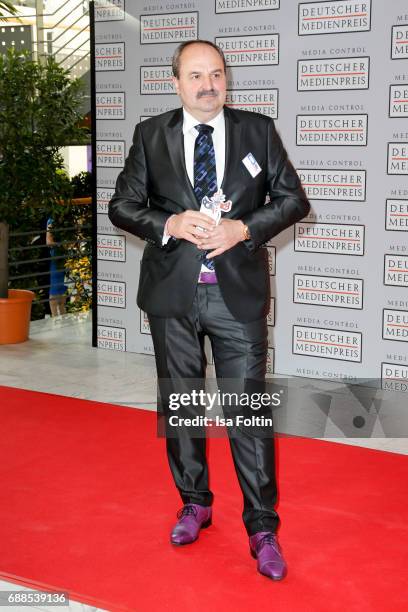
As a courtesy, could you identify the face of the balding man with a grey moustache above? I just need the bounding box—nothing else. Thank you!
[173,43,226,122]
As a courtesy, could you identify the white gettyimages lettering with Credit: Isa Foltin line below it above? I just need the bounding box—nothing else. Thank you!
[164,389,284,428]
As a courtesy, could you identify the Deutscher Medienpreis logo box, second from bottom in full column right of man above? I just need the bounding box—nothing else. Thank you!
[293,274,363,310]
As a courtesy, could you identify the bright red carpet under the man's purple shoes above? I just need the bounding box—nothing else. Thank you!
[0,387,408,612]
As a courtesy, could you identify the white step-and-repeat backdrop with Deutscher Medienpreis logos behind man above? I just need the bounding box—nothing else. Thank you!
[95,0,408,389]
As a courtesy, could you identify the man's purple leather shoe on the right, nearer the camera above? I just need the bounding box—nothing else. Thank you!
[249,531,288,580]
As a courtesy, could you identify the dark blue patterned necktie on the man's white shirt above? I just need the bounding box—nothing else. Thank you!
[194,123,217,270]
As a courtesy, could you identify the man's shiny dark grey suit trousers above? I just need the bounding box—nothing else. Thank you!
[148,284,279,535]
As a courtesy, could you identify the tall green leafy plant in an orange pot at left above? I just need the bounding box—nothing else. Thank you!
[0,49,86,344]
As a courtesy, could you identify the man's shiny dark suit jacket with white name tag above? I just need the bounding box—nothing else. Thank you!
[108,107,310,322]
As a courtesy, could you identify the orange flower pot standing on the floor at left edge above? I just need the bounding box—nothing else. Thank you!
[0,289,35,344]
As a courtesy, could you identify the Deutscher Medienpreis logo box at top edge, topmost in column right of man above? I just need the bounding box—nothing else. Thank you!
[298,0,371,36]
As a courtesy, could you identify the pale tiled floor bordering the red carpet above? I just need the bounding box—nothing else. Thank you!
[0,315,408,612]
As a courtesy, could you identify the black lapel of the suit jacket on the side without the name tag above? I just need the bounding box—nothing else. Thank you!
[165,108,200,210]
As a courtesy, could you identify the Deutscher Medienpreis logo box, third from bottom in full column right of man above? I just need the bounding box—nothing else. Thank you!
[295,222,365,256]
